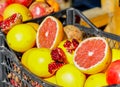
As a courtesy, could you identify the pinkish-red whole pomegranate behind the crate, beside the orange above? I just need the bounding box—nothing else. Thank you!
[29,1,53,18]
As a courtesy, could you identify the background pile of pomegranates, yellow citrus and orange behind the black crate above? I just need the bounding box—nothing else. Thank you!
[0,0,60,21]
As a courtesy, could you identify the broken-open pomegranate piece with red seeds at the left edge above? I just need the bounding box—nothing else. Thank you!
[0,13,22,33]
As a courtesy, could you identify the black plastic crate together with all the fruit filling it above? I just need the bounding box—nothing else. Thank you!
[0,8,120,87]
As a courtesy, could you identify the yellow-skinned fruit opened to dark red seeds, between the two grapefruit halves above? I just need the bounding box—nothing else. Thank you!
[58,39,79,64]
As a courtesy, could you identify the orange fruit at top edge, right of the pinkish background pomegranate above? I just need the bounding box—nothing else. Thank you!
[46,0,60,12]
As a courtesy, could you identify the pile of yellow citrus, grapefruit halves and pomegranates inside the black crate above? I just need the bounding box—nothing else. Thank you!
[0,10,120,87]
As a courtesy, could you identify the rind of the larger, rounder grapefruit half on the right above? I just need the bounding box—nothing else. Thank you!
[73,37,112,74]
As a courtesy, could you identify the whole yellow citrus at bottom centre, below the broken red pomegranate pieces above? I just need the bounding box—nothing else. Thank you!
[56,64,86,87]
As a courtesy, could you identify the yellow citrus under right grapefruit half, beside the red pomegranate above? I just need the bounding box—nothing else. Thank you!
[84,73,108,87]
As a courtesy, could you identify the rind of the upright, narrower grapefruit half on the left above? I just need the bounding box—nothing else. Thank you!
[36,16,64,49]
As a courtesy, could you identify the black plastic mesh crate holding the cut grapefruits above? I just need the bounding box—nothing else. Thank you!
[0,8,120,87]
